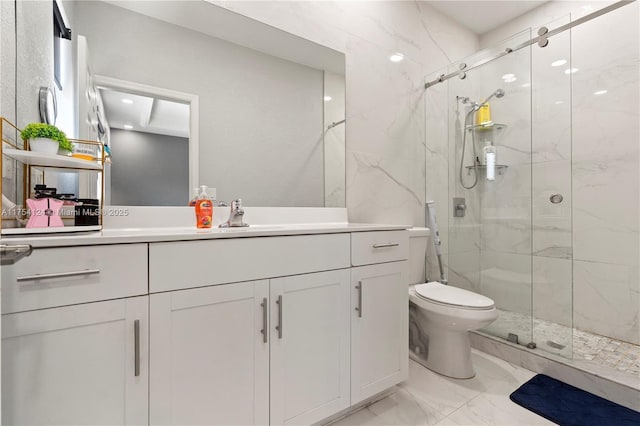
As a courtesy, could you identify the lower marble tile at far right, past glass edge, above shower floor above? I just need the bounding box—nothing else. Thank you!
[573,260,640,345]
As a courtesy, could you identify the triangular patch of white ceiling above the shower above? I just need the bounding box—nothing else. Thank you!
[428,0,549,35]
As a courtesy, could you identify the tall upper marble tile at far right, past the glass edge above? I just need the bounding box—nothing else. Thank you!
[572,3,640,265]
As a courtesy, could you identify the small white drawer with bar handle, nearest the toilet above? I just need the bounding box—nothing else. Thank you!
[351,230,409,266]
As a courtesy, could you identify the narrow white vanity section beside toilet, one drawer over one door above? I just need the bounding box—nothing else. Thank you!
[351,231,409,404]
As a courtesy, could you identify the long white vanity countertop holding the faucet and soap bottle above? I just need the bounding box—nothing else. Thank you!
[2,223,410,247]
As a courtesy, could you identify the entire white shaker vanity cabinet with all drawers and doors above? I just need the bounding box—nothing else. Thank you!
[2,225,409,426]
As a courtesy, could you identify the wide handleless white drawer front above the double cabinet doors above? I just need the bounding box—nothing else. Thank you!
[149,234,350,293]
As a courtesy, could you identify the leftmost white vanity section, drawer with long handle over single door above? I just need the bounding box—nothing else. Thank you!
[2,244,149,425]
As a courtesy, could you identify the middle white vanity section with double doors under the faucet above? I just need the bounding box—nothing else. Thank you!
[149,233,350,425]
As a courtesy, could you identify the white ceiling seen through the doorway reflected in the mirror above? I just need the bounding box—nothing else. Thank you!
[99,88,189,138]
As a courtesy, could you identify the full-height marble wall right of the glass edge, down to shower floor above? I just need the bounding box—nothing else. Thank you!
[572,2,640,344]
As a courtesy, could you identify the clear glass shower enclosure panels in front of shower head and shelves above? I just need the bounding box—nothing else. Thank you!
[425,17,573,357]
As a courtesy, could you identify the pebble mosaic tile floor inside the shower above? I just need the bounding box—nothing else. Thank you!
[481,310,640,382]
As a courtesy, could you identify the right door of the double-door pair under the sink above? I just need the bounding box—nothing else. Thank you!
[271,269,350,425]
